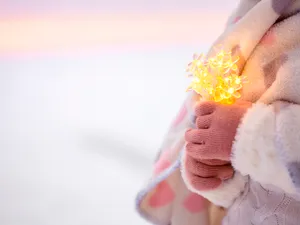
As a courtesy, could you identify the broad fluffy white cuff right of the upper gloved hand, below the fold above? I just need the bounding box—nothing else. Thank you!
[232,101,300,193]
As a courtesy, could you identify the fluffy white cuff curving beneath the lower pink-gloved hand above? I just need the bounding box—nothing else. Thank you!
[181,153,247,208]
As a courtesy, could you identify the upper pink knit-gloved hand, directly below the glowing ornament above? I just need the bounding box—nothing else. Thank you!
[185,101,252,161]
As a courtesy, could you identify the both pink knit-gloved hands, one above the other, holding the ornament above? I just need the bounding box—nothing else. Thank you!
[184,101,252,190]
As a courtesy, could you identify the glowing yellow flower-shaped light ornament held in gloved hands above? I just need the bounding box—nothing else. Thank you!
[187,46,247,104]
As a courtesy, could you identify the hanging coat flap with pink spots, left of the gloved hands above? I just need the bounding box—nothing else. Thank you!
[137,92,214,225]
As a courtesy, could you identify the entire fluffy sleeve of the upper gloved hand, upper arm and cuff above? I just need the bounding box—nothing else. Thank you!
[232,48,300,194]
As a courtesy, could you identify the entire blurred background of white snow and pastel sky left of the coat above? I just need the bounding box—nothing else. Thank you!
[0,0,235,225]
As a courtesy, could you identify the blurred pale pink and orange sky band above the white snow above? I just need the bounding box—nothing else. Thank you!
[0,0,235,55]
